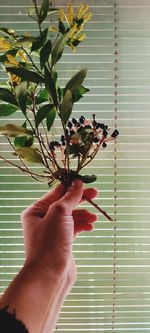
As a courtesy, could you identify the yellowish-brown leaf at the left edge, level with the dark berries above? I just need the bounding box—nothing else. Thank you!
[0,124,33,137]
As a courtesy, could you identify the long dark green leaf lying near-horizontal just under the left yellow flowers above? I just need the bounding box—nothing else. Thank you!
[6,67,44,83]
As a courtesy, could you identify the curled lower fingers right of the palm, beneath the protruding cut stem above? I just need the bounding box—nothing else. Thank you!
[72,209,97,236]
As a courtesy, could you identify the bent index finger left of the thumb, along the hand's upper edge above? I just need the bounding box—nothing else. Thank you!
[21,184,66,218]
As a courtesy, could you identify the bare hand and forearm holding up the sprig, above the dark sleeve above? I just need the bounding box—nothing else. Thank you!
[0,180,97,333]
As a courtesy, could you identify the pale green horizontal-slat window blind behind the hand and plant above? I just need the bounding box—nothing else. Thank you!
[0,0,150,333]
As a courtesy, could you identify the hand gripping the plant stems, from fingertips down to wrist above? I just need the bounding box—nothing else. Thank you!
[21,180,97,279]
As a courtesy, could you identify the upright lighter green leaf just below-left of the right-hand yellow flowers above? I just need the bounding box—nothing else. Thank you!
[52,34,68,67]
